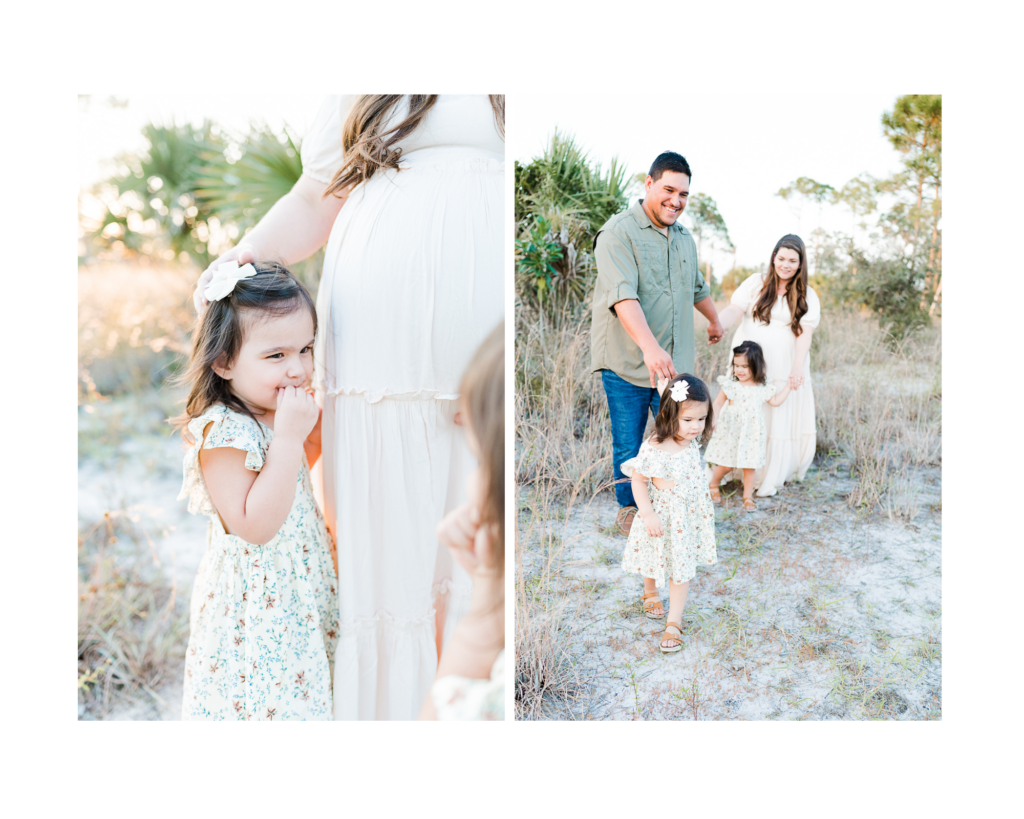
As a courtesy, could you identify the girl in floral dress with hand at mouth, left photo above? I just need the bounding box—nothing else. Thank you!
[172,262,338,722]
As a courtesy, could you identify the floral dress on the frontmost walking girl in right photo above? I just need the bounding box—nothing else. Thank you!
[623,441,718,589]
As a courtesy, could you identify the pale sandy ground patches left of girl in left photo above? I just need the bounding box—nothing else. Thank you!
[78,413,208,722]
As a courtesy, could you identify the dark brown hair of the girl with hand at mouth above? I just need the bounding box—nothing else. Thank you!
[168,262,316,443]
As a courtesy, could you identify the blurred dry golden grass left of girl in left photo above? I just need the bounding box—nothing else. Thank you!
[77,264,199,716]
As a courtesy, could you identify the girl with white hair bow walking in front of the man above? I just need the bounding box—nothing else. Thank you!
[622,374,718,654]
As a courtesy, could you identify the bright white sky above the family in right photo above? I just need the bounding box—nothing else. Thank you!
[513,94,900,277]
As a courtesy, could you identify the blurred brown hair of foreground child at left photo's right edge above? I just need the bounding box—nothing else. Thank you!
[459,318,507,634]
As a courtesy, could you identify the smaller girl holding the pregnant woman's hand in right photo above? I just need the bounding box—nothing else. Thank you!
[705,341,790,512]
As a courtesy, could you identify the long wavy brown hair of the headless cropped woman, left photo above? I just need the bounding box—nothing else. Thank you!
[324,94,505,197]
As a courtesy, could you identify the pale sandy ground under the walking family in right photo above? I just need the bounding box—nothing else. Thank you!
[520,460,943,720]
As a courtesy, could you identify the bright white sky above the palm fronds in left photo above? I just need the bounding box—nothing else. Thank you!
[78,93,327,192]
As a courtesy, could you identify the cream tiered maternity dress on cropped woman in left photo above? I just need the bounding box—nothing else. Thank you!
[302,93,508,720]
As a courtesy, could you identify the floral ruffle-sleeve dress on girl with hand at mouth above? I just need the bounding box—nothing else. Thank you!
[178,405,338,722]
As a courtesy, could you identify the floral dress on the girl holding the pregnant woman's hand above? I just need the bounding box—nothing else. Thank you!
[705,376,778,469]
